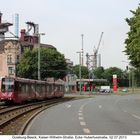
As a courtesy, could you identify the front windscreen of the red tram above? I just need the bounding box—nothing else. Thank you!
[1,78,14,92]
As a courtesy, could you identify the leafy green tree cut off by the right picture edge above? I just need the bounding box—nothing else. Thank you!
[124,7,140,68]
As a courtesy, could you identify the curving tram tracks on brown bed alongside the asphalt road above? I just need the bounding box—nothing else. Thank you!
[0,97,75,135]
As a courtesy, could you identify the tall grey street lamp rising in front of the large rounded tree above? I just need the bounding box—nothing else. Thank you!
[38,33,45,80]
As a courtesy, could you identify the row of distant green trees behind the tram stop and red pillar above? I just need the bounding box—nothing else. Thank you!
[73,65,129,87]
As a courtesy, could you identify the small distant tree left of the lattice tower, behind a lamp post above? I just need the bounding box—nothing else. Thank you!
[73,65,89,79]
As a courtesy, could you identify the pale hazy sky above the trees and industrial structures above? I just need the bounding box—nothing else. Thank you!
[0,0,140,69]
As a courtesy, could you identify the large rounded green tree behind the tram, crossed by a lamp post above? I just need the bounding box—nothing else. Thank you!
[16,48,67,80]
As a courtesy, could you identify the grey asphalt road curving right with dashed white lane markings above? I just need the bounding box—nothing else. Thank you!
[26,94,140,135]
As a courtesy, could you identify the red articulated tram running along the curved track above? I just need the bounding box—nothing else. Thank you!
[0,77,65,103]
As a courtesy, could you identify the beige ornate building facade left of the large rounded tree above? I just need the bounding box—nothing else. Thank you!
[0,40,21,77]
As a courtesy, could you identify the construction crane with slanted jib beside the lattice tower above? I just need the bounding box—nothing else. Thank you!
[93,32,104,69]
